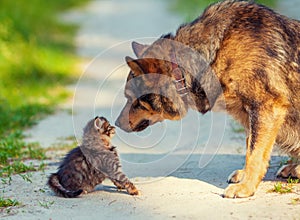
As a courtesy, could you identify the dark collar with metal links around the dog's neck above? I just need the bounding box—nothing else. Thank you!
[171,52,188,97]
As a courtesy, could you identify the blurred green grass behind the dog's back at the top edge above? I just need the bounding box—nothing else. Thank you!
[171,0,277,22]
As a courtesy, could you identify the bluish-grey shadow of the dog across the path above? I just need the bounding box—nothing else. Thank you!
[122,154,287,188]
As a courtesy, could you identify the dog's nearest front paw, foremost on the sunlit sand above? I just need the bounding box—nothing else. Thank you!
[223,183,255,199]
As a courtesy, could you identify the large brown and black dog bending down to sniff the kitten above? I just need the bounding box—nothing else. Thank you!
[116,0,300,198]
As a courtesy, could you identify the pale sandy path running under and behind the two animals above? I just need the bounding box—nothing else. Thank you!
[0,0,300,219]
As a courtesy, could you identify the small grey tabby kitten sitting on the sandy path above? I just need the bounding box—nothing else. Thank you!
[48,117,139,198]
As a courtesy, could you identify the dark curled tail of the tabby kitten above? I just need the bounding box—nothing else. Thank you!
[48,173,83,198]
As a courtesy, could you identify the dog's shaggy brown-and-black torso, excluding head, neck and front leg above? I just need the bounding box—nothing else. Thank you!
[174,1,300,157]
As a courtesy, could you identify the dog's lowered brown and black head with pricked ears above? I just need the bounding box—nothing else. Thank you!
[116,42,187,132]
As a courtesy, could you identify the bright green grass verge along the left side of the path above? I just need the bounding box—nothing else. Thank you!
[0,0,88,181]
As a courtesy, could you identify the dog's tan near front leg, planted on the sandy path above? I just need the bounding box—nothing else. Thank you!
[224,101,287,198]
